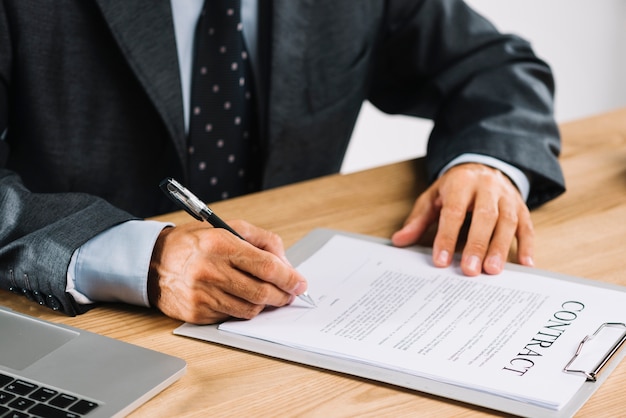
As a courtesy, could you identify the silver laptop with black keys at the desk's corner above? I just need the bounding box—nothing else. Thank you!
[0,307,187,418]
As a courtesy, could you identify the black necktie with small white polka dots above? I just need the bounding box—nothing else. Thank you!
[188,0,258,202]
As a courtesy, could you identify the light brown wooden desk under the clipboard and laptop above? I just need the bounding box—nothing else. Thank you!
[0,109,626,417]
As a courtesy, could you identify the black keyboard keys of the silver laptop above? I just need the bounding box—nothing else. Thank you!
[0,373,98,418]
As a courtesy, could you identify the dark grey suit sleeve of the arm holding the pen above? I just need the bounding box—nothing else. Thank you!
[0,2,132,315]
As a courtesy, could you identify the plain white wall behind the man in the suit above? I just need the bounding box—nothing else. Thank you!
[342,0,626,173]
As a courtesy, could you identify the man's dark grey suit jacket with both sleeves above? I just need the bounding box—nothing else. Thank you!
[0,0,564,314]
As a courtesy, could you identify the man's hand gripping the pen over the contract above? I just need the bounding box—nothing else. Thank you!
[148,221,307,324]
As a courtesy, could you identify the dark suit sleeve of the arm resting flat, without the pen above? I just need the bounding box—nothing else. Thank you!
[369,0,565,207]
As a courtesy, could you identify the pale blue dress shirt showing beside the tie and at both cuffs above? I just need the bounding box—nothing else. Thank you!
[66,0,529,306]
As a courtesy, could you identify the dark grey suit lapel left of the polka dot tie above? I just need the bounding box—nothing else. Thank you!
[95,0,186,162]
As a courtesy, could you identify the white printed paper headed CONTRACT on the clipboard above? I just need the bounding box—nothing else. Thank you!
[176,235,626,410]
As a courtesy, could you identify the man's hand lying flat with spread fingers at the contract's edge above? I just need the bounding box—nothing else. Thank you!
[392,163,534,276]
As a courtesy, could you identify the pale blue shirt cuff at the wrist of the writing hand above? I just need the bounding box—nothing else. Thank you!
[66,220,172,307]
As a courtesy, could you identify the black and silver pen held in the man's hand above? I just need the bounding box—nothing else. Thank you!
[159,177,316,306]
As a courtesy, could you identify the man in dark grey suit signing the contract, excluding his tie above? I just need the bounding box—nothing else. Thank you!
[0,0,564,323]
